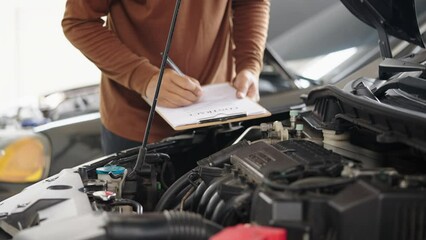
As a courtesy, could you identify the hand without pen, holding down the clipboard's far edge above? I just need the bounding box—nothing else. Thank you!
[233,69,259,102]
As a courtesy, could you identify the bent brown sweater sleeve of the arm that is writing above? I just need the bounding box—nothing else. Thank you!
[62,0,158,95]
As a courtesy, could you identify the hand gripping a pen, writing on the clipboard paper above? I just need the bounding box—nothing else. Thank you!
[145,69,202,108]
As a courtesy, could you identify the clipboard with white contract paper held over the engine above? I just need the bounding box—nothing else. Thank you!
[145,83,271,131]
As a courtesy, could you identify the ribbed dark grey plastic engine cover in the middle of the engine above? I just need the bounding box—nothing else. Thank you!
[231,140,342,184]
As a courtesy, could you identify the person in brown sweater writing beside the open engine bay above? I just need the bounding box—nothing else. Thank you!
[62,0,270,154]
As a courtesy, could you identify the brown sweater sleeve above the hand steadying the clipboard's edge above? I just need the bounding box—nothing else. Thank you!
[232,0,270,74]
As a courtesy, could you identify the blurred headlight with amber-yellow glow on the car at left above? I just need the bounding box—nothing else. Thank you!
[0,133,50,183]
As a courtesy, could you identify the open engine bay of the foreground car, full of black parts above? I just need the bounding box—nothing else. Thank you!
[1,80,426,240]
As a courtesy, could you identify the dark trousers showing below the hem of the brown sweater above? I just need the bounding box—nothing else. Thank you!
[101,125,142,155]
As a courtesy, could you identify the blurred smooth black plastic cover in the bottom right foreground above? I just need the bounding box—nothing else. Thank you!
[250,180,426,240]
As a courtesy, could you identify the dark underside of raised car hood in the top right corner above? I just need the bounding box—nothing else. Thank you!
[341,0,425,48]
